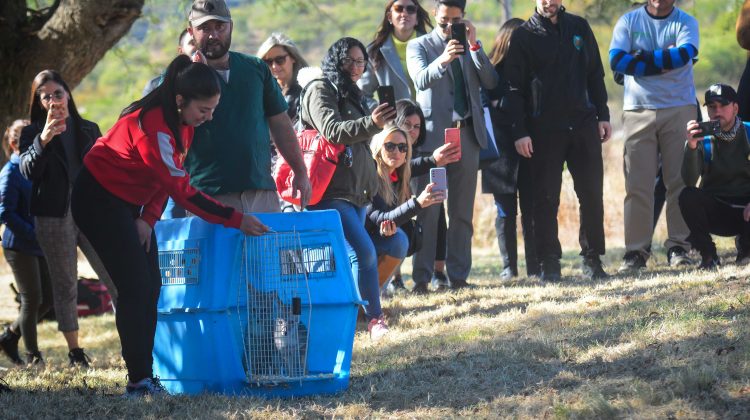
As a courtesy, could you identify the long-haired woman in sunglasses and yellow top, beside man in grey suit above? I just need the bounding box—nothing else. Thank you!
[357,0,432,109]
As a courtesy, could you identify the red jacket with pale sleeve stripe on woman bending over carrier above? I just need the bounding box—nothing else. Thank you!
[83,108,242,228]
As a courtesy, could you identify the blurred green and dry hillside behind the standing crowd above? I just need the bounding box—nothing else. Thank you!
[69,0,747,251]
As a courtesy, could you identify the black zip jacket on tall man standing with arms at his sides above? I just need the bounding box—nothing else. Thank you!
[505,7,609,140]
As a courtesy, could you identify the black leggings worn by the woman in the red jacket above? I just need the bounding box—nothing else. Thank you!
[71,167,161,382]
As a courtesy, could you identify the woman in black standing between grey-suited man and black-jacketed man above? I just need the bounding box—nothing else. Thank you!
[482,18,540,280]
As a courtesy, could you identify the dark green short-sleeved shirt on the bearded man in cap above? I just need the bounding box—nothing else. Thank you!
[185,51,288,195]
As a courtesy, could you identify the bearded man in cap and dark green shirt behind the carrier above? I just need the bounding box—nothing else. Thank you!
[185,0,311,213]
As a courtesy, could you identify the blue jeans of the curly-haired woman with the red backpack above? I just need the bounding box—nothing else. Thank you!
[308,199,383,320]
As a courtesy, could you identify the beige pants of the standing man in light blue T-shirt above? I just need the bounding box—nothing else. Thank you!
[622,105,697,257]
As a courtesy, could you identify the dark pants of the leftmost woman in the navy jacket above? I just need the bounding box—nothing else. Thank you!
[3,248,52,353]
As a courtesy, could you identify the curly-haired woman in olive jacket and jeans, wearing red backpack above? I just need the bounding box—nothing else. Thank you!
[300,37,396,340]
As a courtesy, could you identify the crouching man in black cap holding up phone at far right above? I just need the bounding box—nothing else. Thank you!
[679,84,750,270]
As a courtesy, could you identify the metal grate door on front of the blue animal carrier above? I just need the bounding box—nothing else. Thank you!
[240,232,316,384]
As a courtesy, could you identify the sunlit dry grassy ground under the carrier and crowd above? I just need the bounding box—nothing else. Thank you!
[0,244,750,418]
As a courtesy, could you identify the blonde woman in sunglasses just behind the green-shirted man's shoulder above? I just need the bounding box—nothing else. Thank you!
[256,32,307,120]
